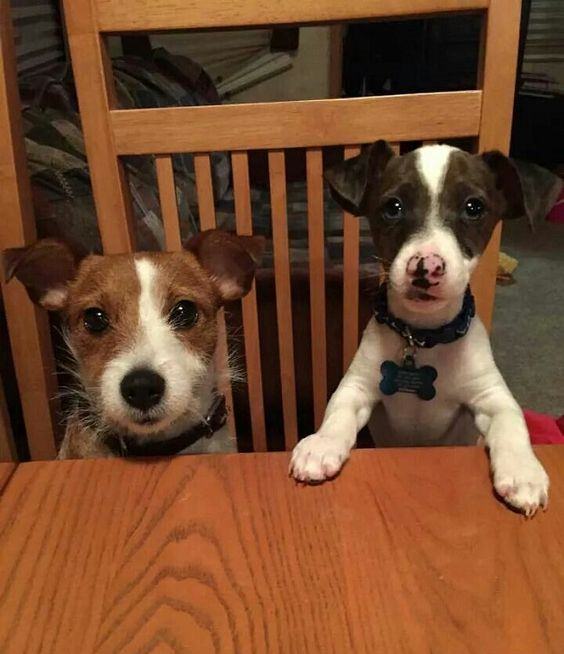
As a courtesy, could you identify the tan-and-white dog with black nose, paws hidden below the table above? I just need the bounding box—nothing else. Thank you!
[4,230,264,458]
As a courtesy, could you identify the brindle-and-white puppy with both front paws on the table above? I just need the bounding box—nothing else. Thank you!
[290,141,549,515]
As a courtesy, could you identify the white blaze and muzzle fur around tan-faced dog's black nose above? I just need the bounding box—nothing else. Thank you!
[101,258,208,433]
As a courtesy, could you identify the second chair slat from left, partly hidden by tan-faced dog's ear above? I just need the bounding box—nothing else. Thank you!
[194,154,237,437]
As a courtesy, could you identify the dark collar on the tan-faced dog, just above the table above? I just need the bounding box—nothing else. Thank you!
[105,395,227,456]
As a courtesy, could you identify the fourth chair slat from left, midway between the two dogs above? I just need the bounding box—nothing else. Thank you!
[268,150,298,449]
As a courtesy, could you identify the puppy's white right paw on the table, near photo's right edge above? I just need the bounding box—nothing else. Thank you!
[492,453,549,517]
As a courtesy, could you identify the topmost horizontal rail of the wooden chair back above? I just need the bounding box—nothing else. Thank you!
[95,0,488,32]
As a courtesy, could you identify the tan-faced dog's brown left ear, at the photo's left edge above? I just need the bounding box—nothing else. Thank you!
[2,238,76,311]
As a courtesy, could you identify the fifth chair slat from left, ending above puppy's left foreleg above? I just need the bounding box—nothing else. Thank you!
[306,148,327,429]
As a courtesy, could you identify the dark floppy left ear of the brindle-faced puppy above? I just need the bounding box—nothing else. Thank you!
[325,141,394,216]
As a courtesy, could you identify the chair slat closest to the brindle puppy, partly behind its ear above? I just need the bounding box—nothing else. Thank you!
[343,147,360,372]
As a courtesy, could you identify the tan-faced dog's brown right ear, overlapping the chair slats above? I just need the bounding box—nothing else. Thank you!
[186,229,265,302]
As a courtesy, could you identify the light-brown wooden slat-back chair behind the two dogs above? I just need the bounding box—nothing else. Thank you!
[0,0,520,462]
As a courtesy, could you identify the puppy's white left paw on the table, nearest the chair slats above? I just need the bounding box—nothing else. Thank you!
[289,434,350,482]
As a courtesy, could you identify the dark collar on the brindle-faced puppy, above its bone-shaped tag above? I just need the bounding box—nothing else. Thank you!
[374,284,476,348]
